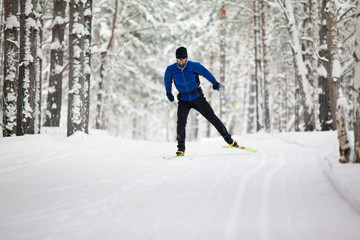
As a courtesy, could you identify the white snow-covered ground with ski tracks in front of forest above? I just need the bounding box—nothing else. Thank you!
[0,132,360,240]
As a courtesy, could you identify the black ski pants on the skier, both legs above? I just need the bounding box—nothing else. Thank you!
[176,96,232,151]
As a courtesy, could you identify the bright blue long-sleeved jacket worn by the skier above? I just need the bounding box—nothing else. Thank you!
[164,61,216,101]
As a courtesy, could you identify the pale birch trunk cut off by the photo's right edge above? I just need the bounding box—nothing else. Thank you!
[354,0,360,163]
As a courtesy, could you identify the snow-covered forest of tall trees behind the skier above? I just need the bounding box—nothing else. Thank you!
[0,0,360,163]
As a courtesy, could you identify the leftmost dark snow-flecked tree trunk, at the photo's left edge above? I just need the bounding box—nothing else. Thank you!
[3,0,20,137]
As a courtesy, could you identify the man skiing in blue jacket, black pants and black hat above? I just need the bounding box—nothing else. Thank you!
[164,47,238,156]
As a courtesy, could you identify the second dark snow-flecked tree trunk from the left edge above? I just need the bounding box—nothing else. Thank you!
[17,0,38,135]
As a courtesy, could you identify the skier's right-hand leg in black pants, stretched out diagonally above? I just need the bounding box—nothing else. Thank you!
[193,97,233,144]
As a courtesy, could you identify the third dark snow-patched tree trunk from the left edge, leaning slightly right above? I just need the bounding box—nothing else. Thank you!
[44,0,67,127]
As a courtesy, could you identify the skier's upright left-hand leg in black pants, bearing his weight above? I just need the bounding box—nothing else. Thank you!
[176,101,191,152]
